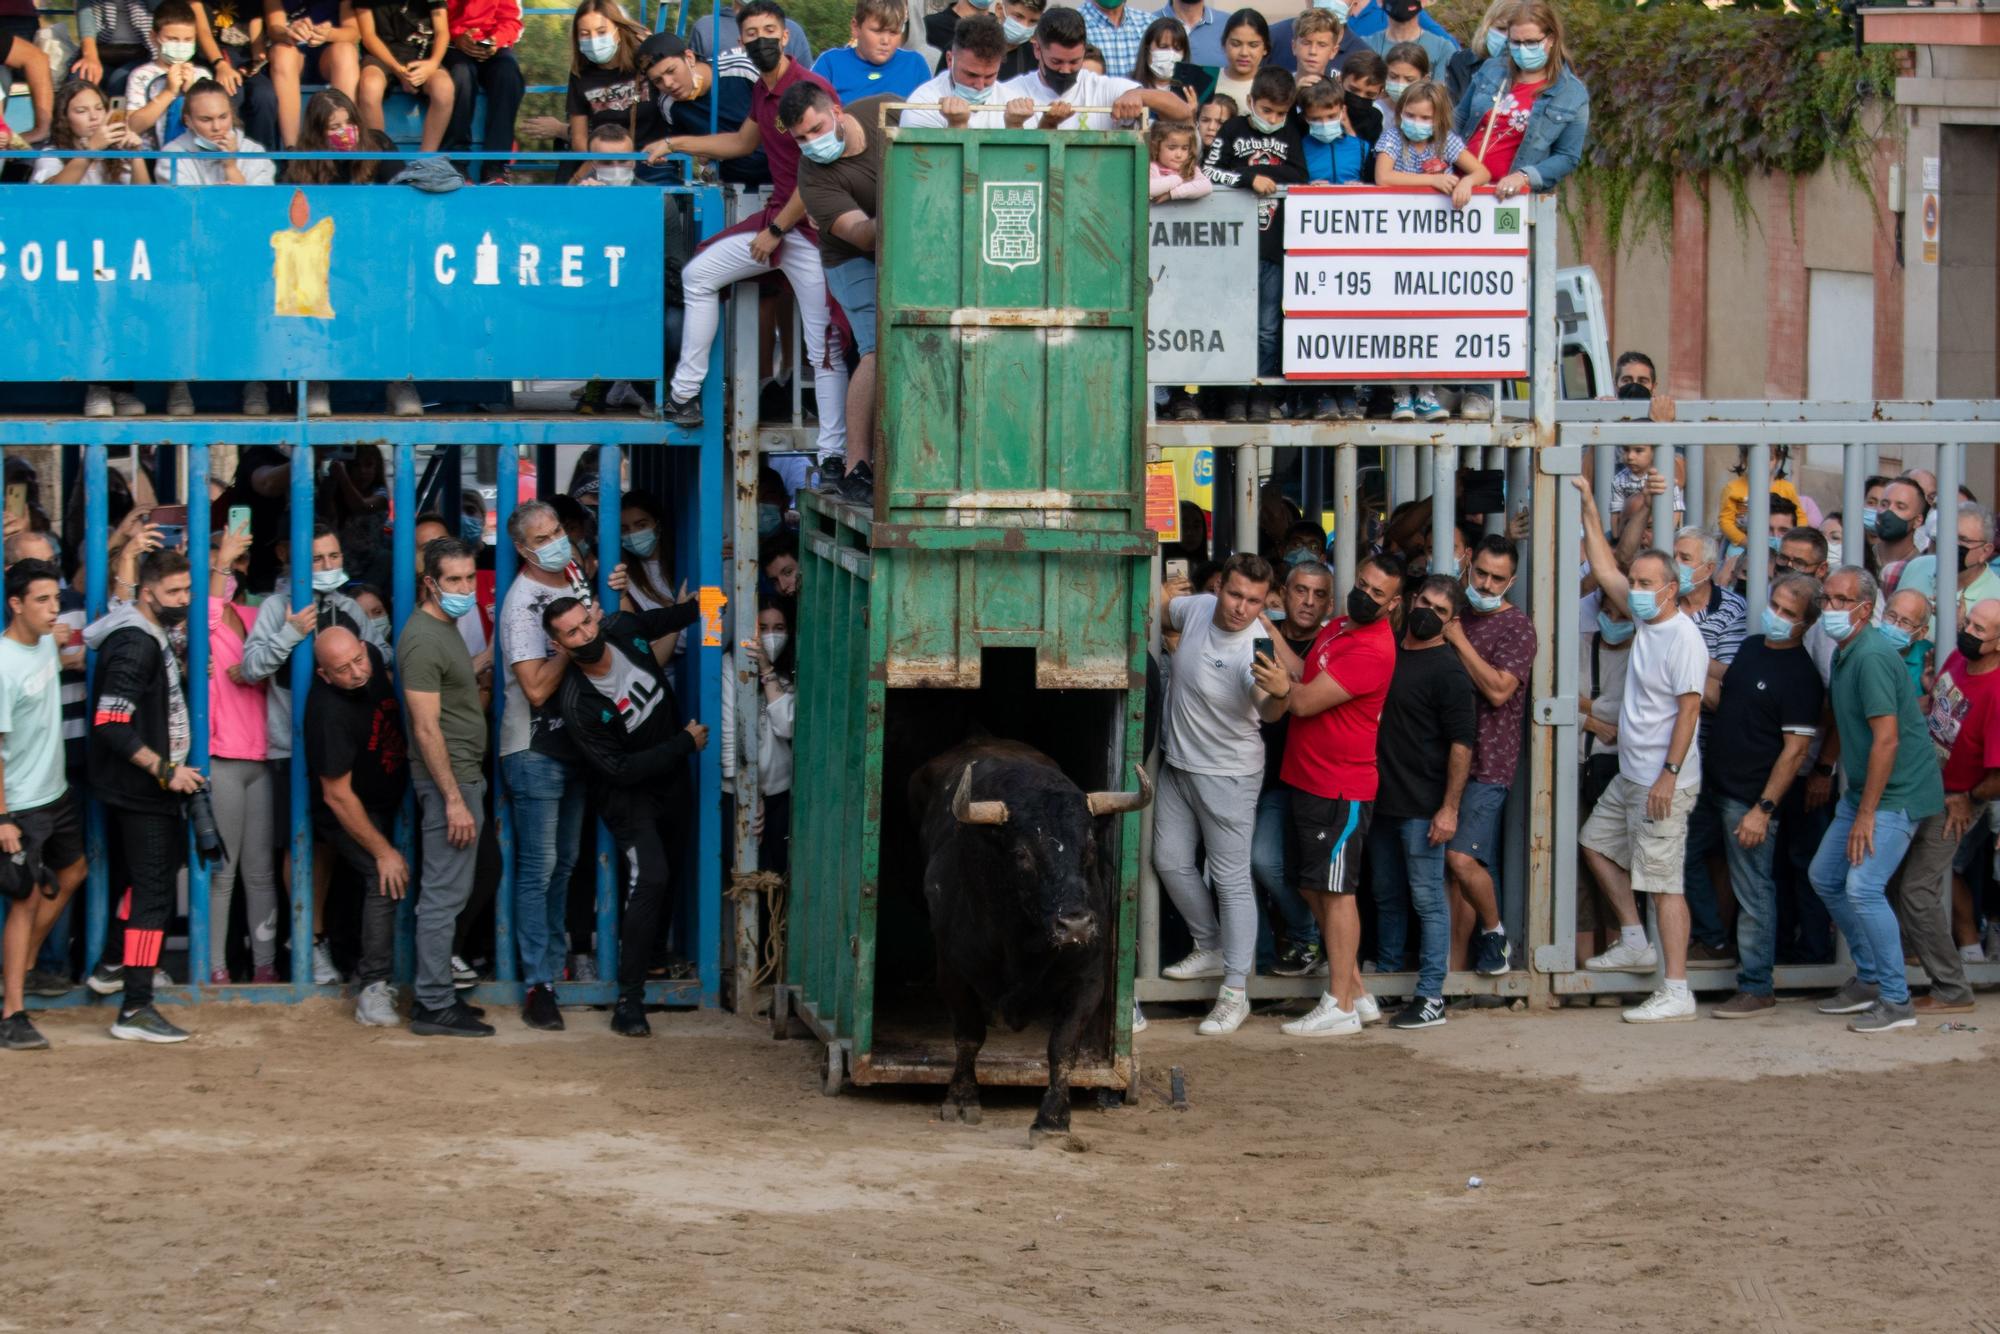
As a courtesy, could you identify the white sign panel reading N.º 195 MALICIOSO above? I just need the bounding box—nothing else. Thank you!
[1284,252,1528,318]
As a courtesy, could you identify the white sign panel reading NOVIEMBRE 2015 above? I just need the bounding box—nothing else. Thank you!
[1284,316,1528,384]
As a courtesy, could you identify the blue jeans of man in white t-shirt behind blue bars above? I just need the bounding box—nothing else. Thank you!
[500,750,584,986]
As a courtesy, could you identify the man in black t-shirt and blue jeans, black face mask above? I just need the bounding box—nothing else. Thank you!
[1368,574,1480,1028]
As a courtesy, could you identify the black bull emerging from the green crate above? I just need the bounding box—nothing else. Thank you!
[910,740,1152,1132]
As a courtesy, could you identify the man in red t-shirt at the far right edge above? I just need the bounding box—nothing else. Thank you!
[1888,598,2000,1018]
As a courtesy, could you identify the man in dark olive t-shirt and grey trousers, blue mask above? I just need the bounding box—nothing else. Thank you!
[396,538,494,1038]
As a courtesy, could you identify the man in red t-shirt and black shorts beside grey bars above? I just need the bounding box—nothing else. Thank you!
[1254,556,1402,1038]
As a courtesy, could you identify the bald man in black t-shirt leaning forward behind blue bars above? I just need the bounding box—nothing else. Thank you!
[306,626,410,1028]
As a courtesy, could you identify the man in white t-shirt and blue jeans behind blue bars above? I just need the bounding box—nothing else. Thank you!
[494,500,592,1030]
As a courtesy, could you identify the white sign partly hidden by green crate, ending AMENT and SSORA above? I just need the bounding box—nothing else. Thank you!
[1146,190,1258,384]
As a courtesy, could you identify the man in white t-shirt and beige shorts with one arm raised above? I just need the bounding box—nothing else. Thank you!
[1570,476,1708,1024]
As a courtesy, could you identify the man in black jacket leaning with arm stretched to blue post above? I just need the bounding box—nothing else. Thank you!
[542,598,708,1038]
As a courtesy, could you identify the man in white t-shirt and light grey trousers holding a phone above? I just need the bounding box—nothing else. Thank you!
[1152,552,1286,1034]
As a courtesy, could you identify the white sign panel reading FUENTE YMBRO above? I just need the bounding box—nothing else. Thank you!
[1284,186,1528,254]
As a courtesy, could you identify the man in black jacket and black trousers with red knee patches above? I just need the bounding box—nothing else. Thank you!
[84,550,206,1042]
